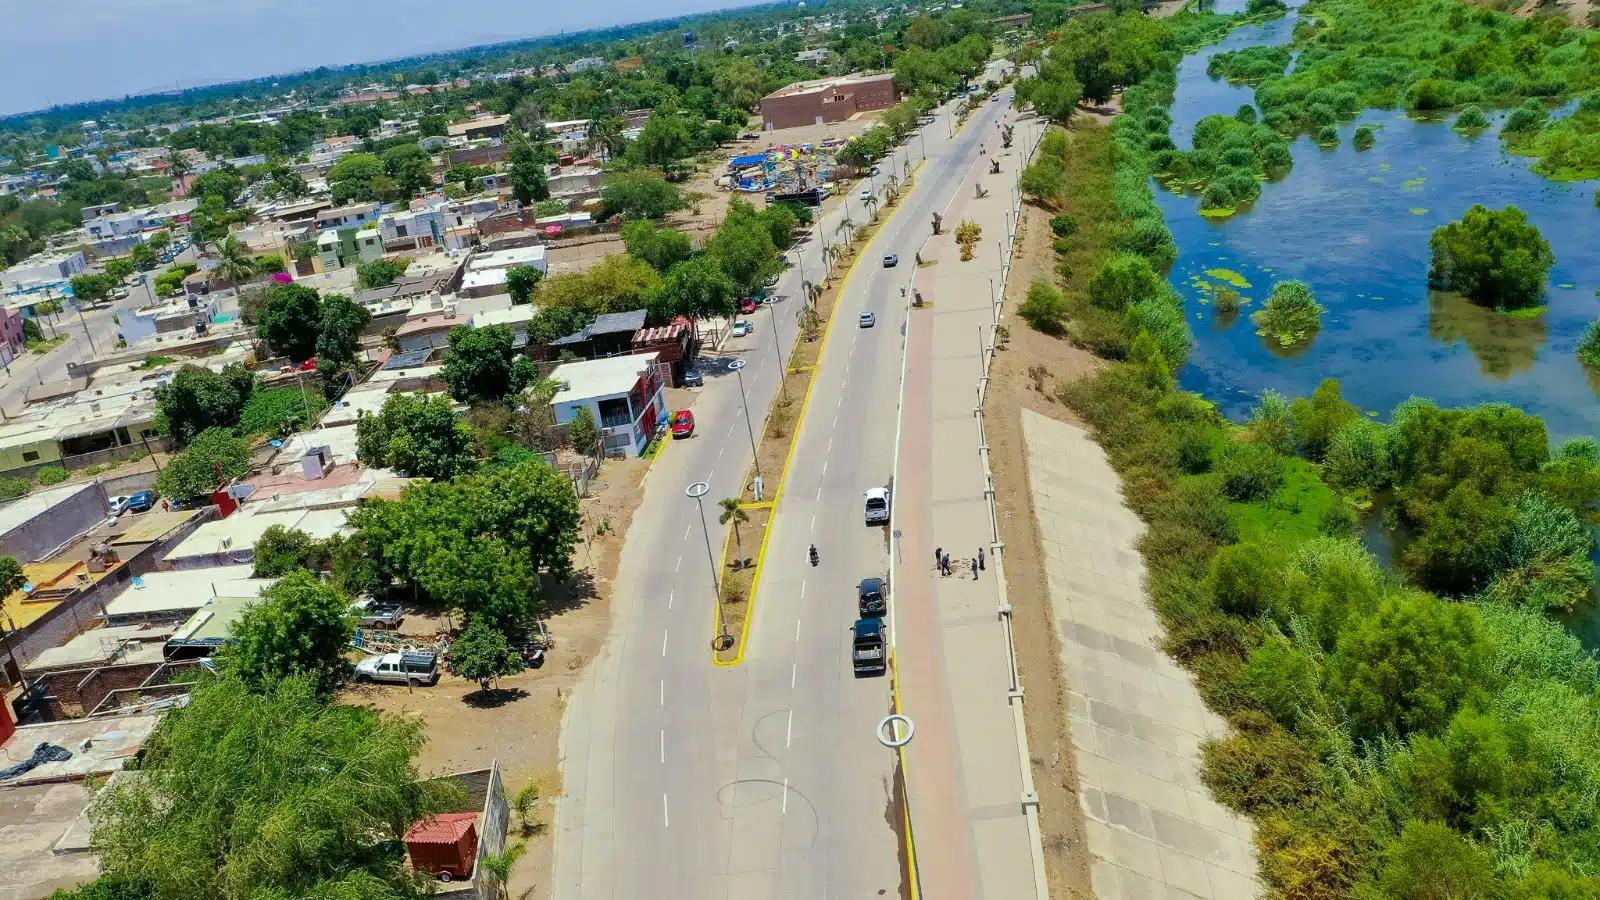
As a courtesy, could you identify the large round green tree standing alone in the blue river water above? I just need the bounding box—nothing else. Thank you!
[1427,203,1555,309]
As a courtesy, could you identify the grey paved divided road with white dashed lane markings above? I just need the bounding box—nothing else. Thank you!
[555,68,1000,900]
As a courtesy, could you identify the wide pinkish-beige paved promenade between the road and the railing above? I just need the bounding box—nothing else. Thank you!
[894,94,1046,900]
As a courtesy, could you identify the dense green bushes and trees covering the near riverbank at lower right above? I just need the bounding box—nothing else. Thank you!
[1019,12,1600,900]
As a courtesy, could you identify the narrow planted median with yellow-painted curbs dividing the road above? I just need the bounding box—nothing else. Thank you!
[712,159,926,668]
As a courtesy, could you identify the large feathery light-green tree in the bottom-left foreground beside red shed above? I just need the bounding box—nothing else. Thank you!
[90,677,466,900]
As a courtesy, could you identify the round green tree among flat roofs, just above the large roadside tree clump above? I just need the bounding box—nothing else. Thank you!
[355,394,474,479]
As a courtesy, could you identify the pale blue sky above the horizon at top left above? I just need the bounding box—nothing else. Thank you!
[0,0,754,115]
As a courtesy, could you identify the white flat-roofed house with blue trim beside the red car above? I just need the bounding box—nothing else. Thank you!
[550,352,672,456]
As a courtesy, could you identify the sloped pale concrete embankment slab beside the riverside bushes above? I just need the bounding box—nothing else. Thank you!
[1022,410,1259,900]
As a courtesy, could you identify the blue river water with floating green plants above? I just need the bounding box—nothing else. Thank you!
[1155,0,1600,647]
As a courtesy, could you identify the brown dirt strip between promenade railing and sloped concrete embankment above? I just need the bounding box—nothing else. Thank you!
[984,185,1099,900]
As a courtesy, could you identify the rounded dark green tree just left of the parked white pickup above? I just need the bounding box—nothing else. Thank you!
[222,569,354,697]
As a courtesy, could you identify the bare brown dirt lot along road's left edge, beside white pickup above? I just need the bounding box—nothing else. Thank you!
[344,451,649,900]
